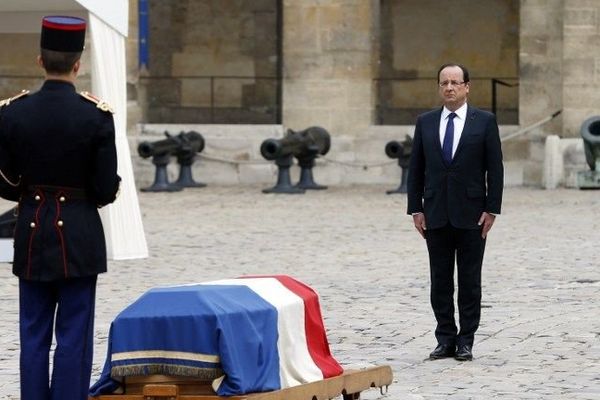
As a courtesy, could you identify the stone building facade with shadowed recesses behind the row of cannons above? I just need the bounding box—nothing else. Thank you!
[0,0,600,185]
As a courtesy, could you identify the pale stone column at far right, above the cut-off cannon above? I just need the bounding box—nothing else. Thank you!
[561,0,600,138]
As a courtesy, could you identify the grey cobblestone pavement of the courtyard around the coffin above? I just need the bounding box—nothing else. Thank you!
[0,186,600,400]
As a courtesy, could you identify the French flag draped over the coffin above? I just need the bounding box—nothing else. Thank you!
[90,275,343,396]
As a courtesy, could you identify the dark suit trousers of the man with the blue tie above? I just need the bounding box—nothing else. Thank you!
[425,224,485,346]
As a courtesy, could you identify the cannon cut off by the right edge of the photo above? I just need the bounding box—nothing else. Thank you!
[577,116,600,189]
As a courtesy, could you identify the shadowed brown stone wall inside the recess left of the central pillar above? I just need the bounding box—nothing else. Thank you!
[145,0,277,122]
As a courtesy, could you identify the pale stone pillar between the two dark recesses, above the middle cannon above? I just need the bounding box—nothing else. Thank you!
[282,0,378,137]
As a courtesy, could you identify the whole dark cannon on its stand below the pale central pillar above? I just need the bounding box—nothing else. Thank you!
[260,126,331,194]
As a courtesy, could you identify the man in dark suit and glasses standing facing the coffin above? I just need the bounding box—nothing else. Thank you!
[408,64,504,361]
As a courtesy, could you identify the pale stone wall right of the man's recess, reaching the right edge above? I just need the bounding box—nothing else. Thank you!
[509,0,600,185]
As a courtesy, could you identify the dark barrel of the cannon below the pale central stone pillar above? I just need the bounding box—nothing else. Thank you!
[260,126,331,160]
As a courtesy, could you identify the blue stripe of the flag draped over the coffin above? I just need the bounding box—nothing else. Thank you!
[94,285,281,396]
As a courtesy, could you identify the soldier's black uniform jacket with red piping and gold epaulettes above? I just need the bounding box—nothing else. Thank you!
[0,80,120,281]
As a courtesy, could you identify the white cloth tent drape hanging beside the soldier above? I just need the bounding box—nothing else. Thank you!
[89,13,148,260]
